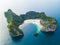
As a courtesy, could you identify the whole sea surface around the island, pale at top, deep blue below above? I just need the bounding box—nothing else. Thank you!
[0,0,60,45]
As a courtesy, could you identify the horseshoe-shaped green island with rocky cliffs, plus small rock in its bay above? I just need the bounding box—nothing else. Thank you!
[4,9,57,37]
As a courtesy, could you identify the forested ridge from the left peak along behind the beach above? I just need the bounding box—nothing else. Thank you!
[5,9,46,26]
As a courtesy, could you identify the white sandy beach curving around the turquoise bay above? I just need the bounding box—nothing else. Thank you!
[19,19,43,32]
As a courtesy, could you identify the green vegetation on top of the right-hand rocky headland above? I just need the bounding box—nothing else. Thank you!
[37,12,55,28]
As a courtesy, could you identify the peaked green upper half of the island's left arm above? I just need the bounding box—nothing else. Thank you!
[5,9,22,26]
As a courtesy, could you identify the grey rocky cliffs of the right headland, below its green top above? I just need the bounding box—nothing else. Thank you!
[40,19,57,32]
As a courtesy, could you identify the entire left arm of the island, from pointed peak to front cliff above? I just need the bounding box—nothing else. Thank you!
[5,9,24,37]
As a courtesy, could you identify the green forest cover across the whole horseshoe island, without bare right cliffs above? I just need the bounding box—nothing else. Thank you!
[5,9,56,35]
